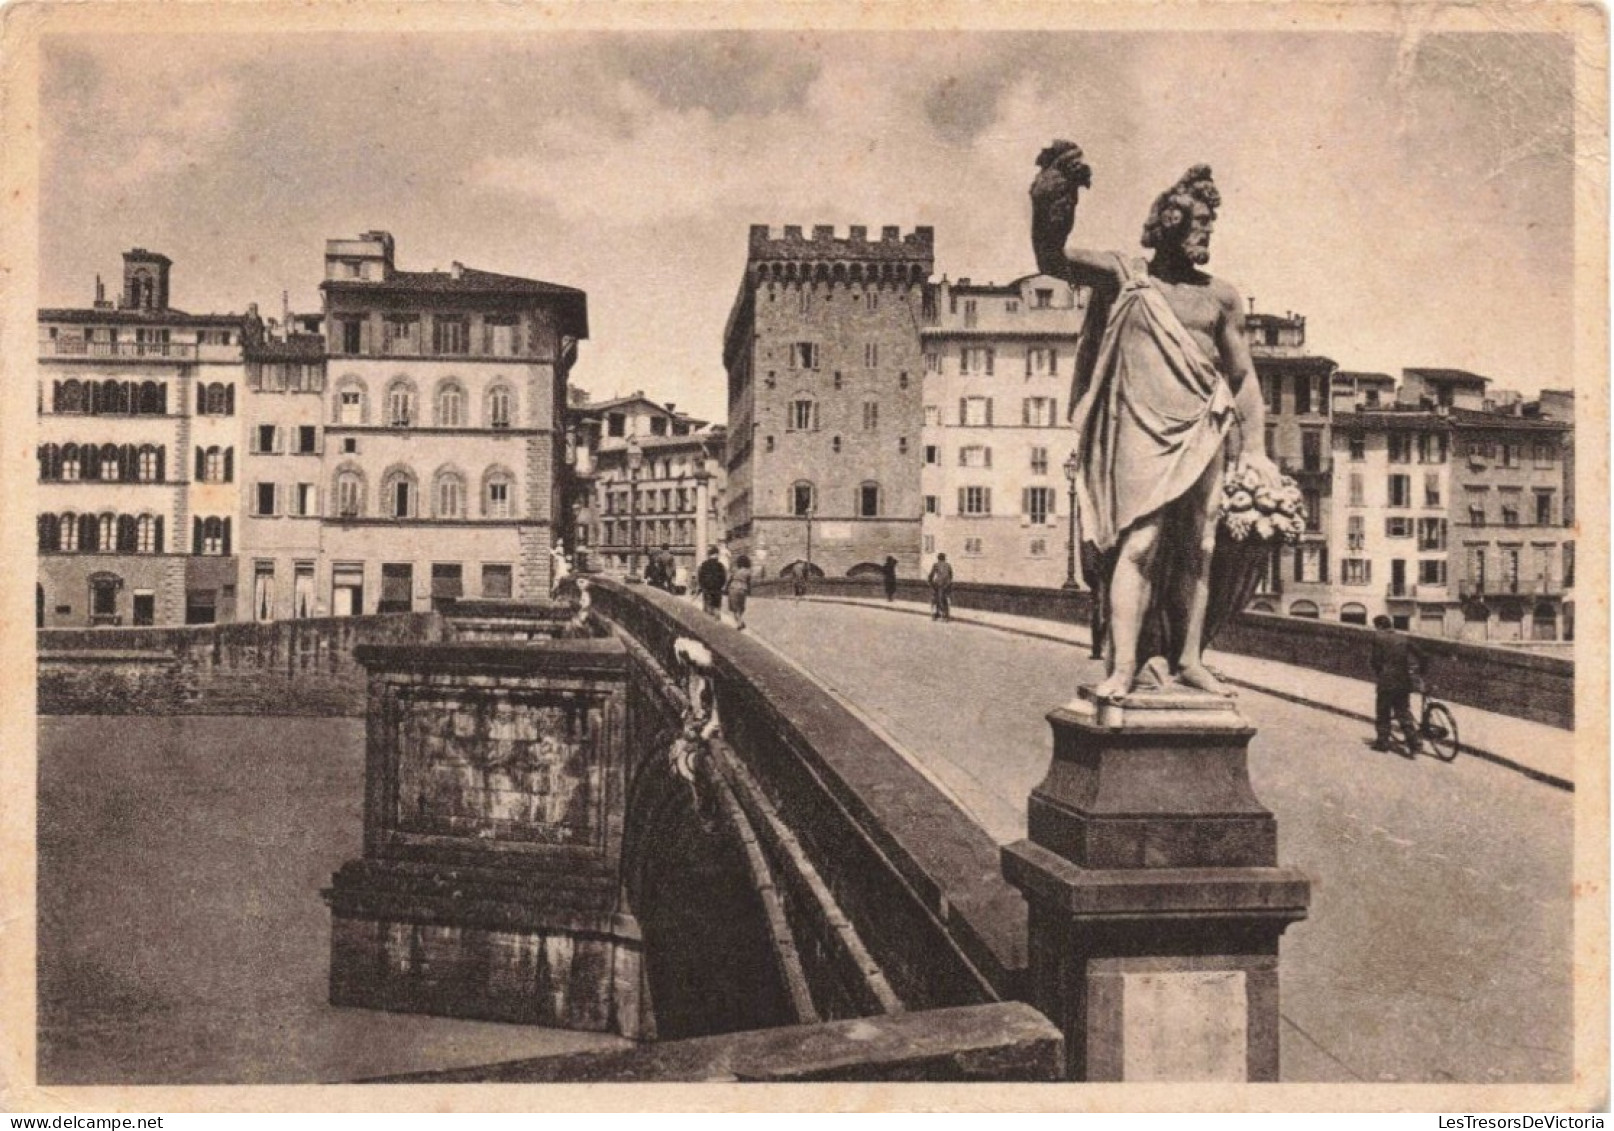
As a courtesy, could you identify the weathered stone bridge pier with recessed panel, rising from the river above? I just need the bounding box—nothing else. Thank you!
[324,641,654,1037]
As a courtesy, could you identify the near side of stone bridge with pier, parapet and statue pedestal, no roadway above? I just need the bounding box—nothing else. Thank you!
[314,581,1307,1079]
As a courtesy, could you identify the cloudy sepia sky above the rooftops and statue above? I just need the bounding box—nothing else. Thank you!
[40,29,1575,421]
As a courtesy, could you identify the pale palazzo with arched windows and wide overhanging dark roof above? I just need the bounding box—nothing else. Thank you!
[317,232,587,615]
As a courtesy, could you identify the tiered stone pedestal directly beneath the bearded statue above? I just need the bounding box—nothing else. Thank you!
[1002,689,1311,1081]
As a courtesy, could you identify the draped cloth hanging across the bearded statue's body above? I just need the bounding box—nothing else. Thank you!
[1072,255,1233,550]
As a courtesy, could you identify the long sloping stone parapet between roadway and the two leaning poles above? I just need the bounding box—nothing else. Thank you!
[592,581,1027,1016]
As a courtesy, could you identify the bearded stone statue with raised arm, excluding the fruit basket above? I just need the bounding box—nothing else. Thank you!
[1031,142,1283,700]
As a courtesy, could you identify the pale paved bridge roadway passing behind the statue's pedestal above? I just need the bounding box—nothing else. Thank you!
[747,599,1574,1083]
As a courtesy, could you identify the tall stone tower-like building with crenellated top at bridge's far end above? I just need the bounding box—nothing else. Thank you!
[723,224,935,576]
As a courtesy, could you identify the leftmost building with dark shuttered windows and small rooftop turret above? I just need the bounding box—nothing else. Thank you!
[36,248,245,626]
